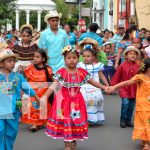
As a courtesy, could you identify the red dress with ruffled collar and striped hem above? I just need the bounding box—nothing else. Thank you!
[45,68,90,141]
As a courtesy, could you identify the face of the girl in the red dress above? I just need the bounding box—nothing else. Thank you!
[65,52,79,68]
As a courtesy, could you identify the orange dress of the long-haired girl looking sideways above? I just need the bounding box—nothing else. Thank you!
[22,65,52,126]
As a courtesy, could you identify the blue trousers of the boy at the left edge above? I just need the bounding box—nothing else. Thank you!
[0,112,20,150]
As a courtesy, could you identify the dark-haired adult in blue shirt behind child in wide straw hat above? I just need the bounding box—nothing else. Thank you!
[79,23,103,46]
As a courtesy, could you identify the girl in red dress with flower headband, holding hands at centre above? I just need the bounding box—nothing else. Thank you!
[41,46,105,150]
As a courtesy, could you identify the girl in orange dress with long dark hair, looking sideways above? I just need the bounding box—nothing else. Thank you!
[22,49,53,131]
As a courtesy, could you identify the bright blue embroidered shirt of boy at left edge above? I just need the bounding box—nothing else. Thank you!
[0,72,35,115]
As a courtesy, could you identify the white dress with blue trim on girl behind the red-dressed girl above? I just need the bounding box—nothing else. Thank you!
[78,62,105,124]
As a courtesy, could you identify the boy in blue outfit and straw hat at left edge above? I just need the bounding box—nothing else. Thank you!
[0,49,39,150]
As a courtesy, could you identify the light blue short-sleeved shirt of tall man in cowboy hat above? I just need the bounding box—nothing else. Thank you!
[38,28,69,73]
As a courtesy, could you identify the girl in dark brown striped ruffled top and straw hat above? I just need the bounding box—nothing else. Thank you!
[13,25,38,72]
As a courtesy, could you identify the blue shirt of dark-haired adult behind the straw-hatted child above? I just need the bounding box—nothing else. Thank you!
[79,32,103,46]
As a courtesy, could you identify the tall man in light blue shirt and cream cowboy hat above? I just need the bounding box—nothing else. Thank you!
[38,11,69,73]
